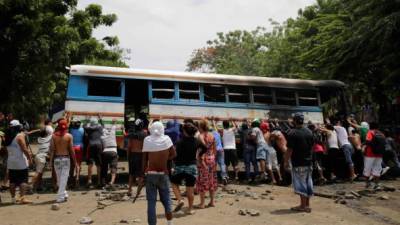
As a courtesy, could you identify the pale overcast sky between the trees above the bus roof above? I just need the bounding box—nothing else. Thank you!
[78,0,315,71]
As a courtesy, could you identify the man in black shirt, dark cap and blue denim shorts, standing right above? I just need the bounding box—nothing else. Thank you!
[285,113,314,213]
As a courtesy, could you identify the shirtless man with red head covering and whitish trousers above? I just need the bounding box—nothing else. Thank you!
[50,119,77,203]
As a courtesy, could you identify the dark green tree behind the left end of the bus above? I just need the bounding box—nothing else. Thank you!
[0,0,126,118]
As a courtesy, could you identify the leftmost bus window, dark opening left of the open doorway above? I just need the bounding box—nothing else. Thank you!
[88,78,121,97]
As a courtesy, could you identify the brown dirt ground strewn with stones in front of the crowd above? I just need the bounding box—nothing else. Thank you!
[0,145,400,225]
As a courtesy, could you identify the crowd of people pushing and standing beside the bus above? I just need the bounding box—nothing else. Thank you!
[0,113,400,224]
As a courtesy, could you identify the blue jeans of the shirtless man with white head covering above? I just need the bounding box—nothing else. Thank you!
[146,174,172,225]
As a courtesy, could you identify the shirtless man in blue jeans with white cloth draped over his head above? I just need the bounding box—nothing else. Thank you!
[143,122,176,225]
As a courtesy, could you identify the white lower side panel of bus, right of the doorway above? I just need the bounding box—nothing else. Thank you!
[149,104,323,123]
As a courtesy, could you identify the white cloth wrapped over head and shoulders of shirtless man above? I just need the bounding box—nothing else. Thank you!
[143,122,173,152]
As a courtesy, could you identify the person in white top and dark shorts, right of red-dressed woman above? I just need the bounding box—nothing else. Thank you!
[222,120,239,180]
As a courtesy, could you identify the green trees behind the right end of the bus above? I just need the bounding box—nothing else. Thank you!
[187,0,400,121]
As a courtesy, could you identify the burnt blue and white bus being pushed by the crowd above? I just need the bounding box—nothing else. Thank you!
[65,65,345,148]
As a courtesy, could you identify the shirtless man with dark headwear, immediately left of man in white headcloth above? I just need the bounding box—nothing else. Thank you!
[128,119,147,196]
